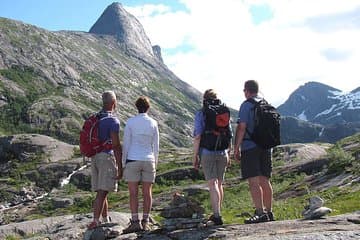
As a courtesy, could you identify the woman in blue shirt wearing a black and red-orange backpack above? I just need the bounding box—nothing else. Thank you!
[193,89,232,225]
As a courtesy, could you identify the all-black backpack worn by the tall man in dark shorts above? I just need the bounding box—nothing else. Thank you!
[246,98,280,149]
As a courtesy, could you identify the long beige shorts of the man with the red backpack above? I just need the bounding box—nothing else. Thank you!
[91,152,118,192]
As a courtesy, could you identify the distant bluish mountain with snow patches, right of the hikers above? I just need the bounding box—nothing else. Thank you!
[278,82,360,143]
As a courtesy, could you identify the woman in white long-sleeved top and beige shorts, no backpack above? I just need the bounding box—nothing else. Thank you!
[122,97,159,233]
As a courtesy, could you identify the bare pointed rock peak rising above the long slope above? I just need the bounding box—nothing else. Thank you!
[89,2,155,58]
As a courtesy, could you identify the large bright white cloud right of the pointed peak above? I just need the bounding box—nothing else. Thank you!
[126,0,360,108]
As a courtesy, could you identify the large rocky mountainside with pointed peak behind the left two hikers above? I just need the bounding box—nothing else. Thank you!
[0,3,201,146]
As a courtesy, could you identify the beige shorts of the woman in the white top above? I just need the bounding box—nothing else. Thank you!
[124,161,156,183]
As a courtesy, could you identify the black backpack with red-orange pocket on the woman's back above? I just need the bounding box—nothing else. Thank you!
[200,99,232,151]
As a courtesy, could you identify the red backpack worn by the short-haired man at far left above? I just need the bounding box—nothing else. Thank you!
[80,113,112,157]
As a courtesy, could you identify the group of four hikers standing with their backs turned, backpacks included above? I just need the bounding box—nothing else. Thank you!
[80,80,280,233]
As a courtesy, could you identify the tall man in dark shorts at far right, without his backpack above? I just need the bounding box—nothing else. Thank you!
[234,80,274,224]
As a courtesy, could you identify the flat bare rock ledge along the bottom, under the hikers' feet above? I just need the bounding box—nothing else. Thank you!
[0,212,360,240]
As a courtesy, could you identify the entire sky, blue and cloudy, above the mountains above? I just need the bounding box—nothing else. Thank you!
[0,0,360,109]
